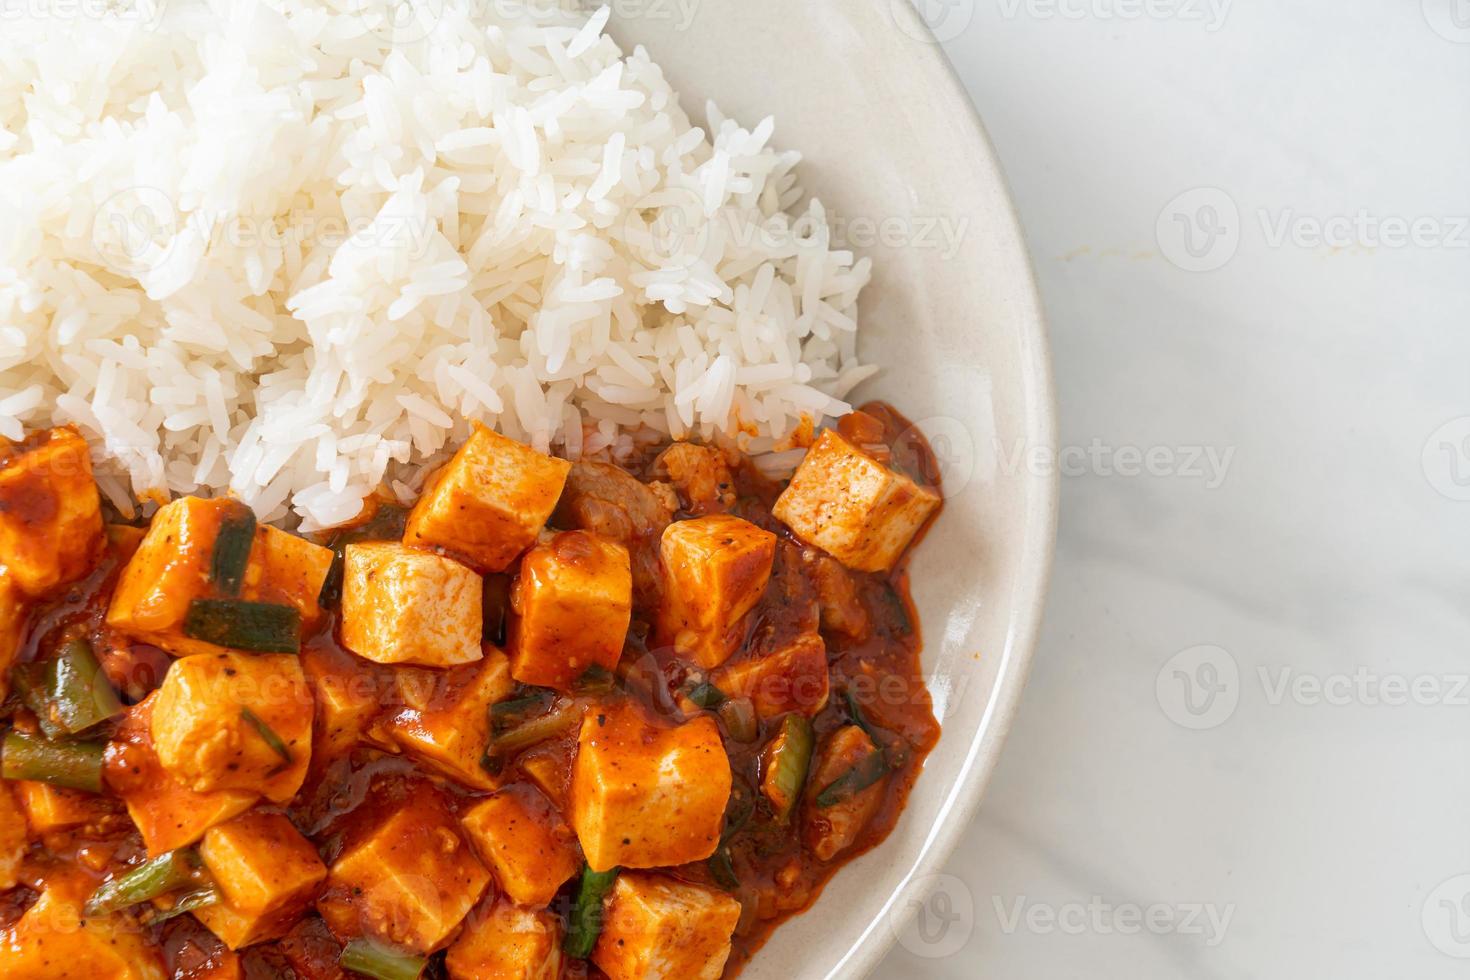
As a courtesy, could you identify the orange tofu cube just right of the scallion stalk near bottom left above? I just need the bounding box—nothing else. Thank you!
[194,810,326,949]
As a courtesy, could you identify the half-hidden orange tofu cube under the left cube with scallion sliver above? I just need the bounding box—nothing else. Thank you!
[107,692,260,857]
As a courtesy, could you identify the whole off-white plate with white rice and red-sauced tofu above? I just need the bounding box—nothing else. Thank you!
[0,0,1055,980]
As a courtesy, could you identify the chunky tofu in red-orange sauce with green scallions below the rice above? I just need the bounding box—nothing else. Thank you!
[0,406,941,980]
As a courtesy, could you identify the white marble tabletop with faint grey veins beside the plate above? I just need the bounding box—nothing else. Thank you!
[878,0,1470,980]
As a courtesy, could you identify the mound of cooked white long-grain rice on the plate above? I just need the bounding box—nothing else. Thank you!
[0,0,870,527]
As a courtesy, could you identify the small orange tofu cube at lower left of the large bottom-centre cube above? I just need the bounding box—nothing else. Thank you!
[460,783,582,908]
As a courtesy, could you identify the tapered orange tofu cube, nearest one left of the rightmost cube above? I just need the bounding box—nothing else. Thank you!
[659,514,776,670]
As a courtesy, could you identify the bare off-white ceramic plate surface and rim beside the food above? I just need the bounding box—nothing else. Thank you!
[613,0,1057,980]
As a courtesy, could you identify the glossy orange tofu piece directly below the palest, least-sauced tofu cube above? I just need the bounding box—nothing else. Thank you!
[387,648,512,789]
